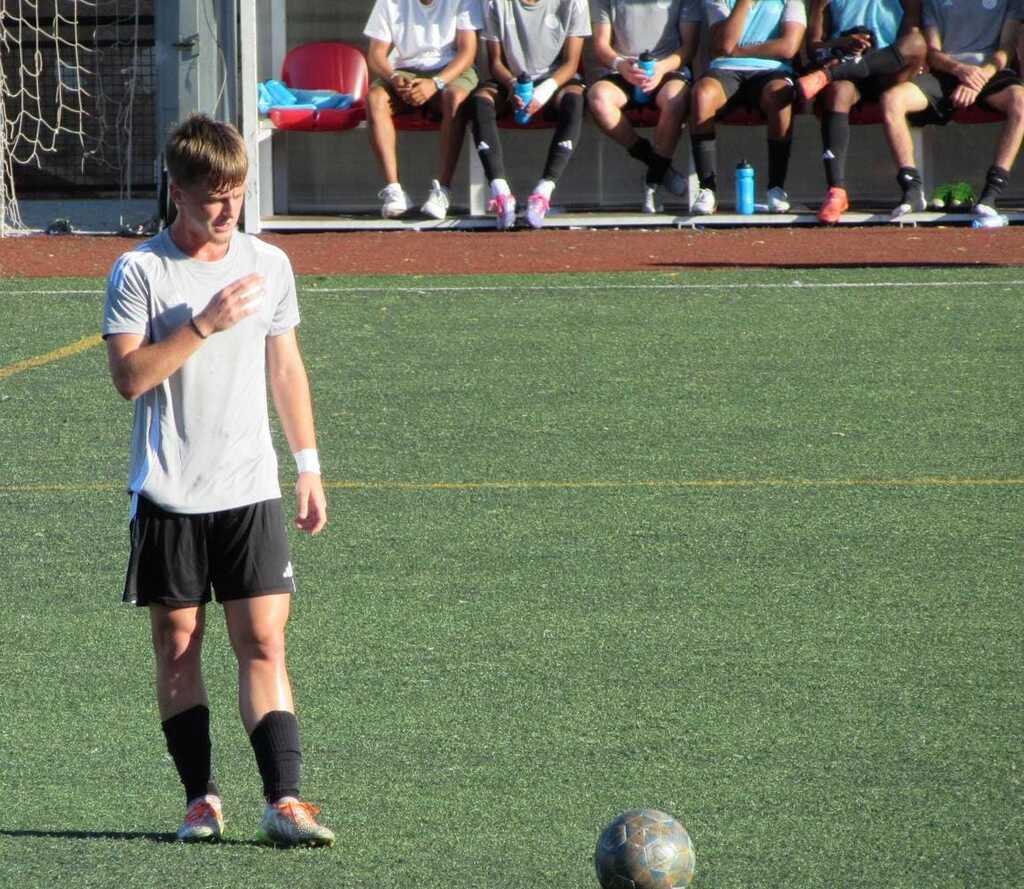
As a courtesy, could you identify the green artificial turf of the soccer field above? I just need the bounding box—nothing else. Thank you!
[0,268,1024,889]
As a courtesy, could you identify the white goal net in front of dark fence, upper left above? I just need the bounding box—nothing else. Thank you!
[0,0,158,236]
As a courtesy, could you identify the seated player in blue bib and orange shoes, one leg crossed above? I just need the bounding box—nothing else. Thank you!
[797,0,929,224]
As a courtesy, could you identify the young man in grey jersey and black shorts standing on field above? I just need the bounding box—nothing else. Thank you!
[102,115,334,846]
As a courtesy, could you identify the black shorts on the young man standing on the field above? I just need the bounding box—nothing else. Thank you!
[124,497,295,607]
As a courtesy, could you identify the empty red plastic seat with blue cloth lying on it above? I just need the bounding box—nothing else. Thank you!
[269,41,369,130]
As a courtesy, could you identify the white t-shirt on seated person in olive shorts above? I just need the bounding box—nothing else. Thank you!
[362,0,483,71]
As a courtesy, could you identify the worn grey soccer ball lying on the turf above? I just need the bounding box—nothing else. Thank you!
[594,809,695,889]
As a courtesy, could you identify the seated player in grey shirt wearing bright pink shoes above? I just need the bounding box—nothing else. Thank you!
[470,0,590,229]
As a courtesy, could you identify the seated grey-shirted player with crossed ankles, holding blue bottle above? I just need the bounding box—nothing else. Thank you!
[587,0,703,213]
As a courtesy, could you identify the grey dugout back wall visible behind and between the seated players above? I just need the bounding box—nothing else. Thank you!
[259,0,1024,213]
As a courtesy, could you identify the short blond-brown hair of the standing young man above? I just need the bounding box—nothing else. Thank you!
[165,114,249,194]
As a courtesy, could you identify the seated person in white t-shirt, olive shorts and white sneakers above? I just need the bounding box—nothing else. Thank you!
[364,0,483,219]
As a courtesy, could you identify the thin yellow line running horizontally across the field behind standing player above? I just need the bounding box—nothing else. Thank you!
[0,477,1024,494]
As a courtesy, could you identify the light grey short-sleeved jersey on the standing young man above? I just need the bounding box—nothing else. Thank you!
[102,229,299,513]
